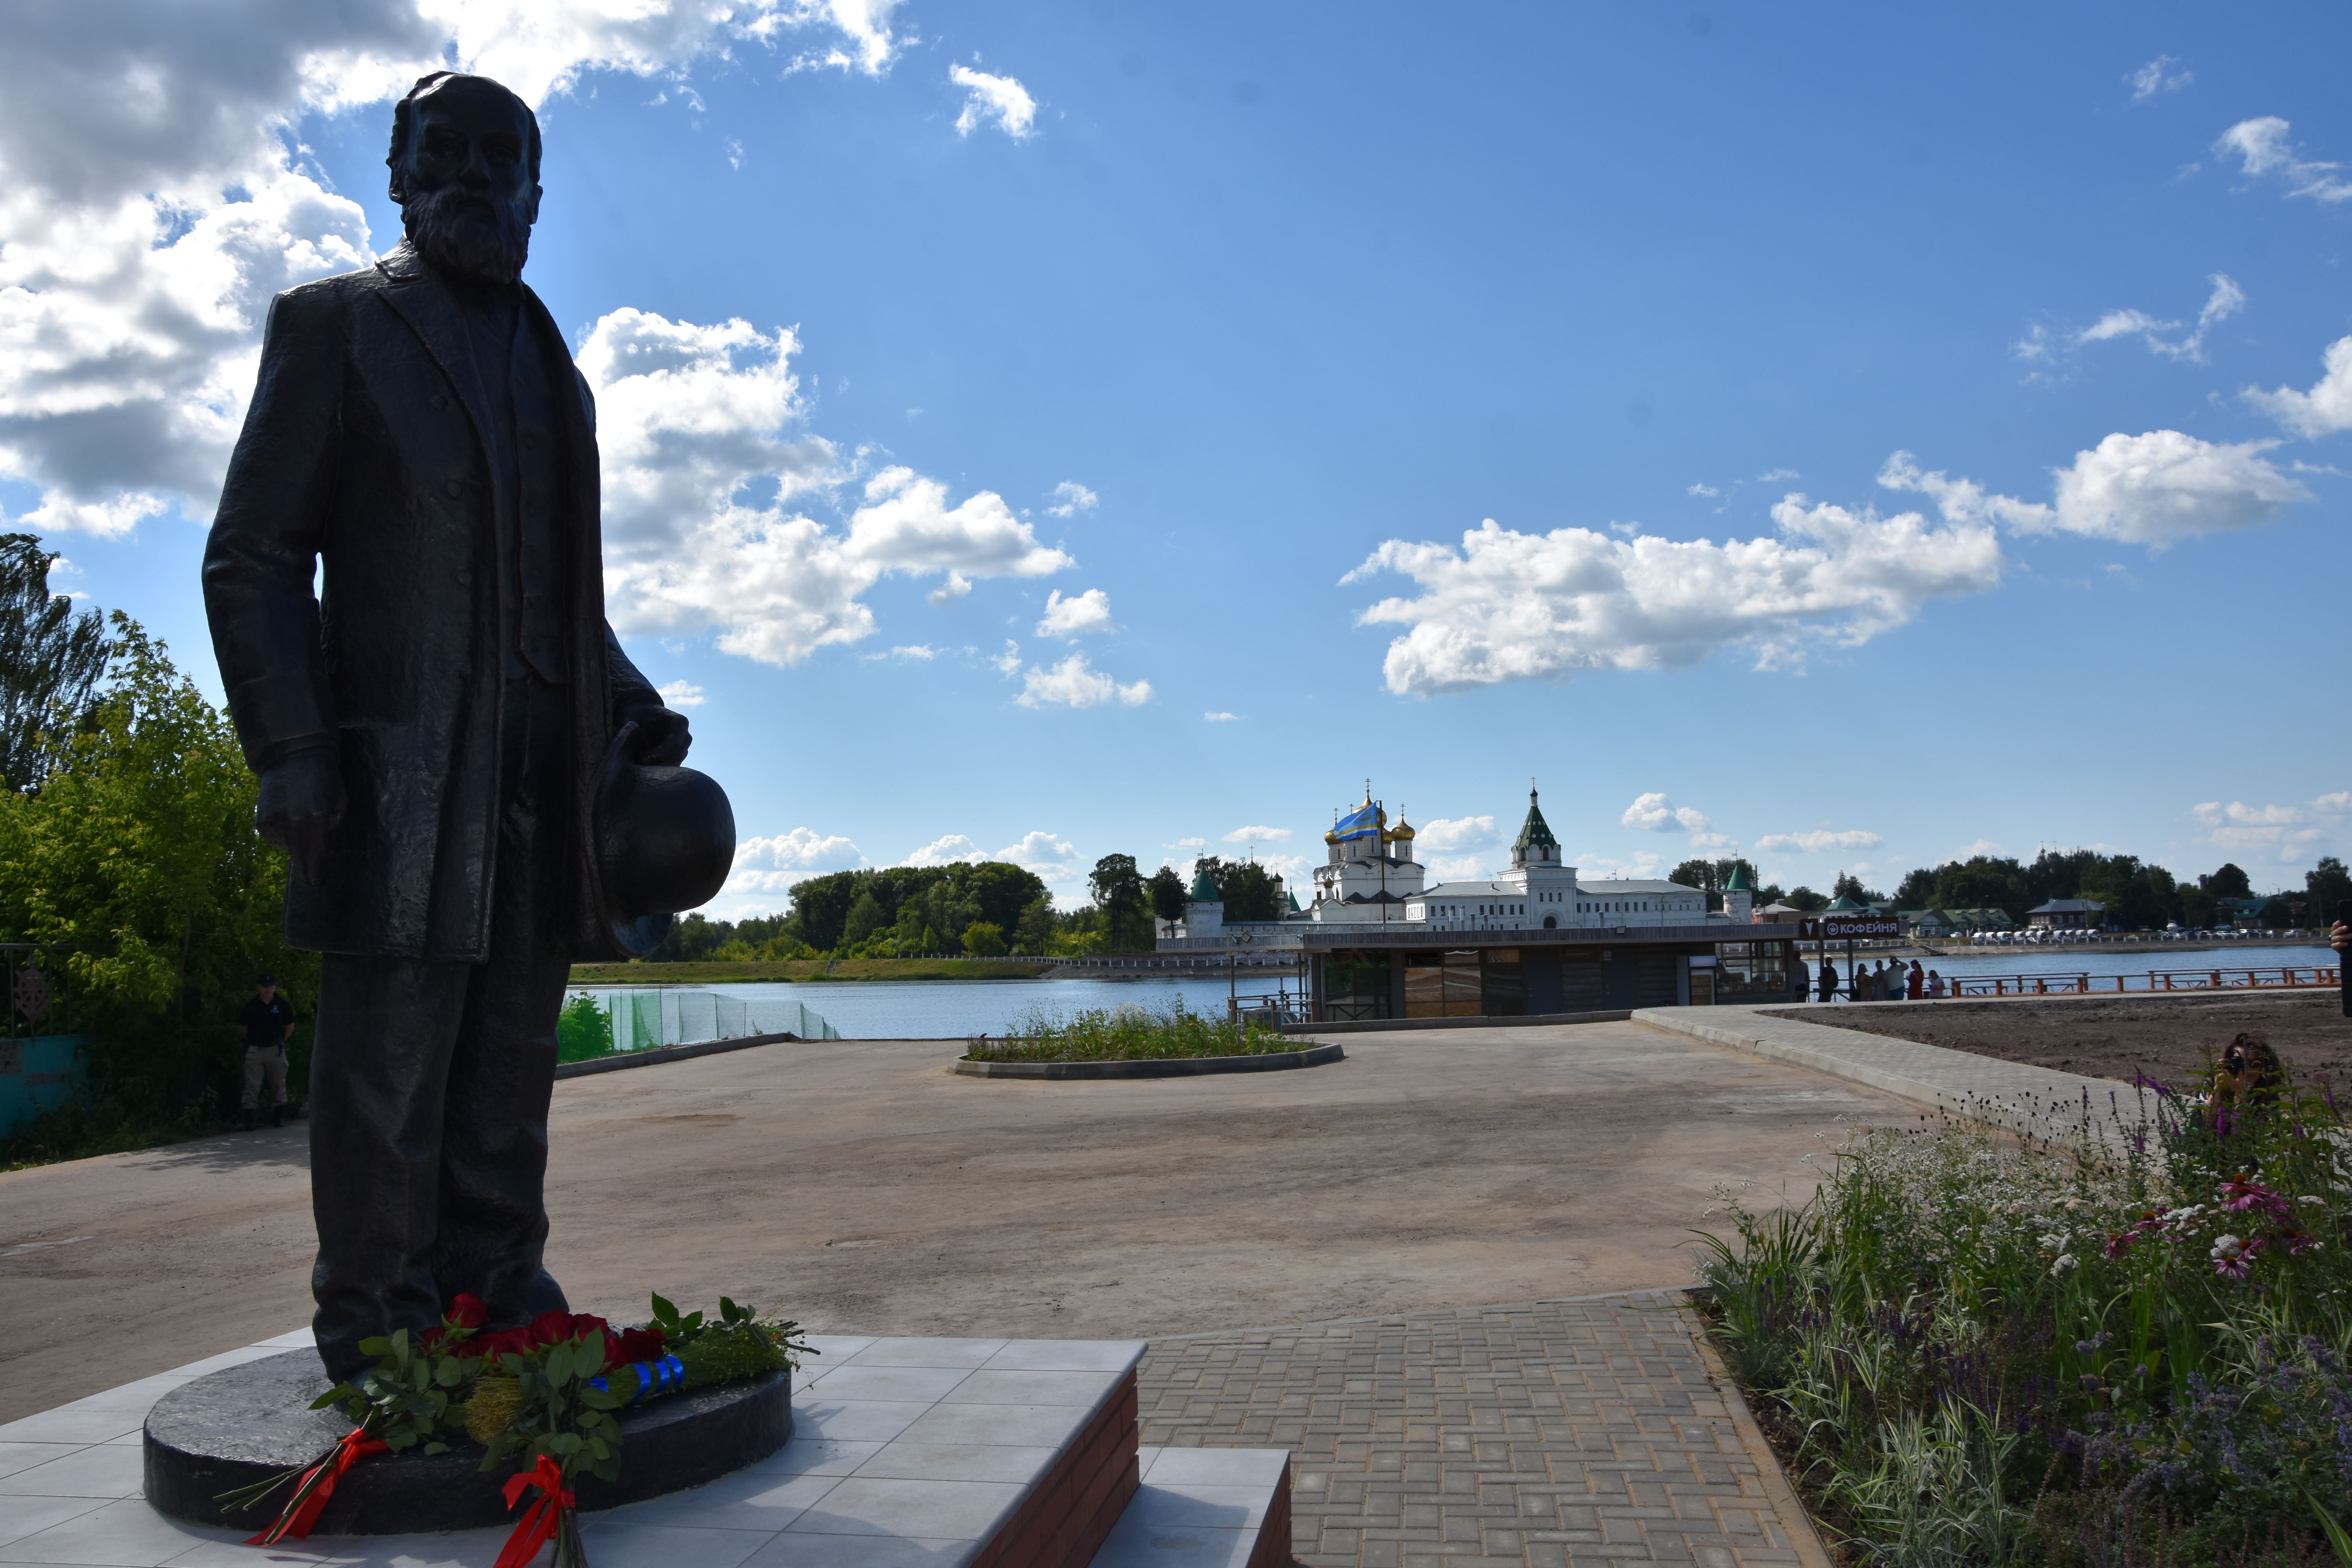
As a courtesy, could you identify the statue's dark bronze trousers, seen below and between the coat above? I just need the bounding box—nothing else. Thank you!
[310,684,569,1377]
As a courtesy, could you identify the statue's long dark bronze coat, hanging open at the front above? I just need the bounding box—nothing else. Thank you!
[205,247,661,964]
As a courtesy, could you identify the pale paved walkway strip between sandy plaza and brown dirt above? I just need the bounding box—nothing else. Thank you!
[1632,1002,2140,1138]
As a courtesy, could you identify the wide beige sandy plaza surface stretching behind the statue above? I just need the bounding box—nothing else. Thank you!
[0,1023,1917,1420]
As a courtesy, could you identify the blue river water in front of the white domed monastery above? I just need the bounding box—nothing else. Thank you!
[583,945,2336,1039]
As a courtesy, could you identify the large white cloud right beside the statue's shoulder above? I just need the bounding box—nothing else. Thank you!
[579,310,1075,665]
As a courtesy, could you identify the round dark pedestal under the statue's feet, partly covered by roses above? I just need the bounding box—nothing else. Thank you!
[146,1349,793,1535]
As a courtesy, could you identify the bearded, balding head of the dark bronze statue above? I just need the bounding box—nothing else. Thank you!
[400,75,539,282]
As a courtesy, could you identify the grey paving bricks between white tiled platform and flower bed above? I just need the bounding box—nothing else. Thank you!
[1138,1290,1828,1568]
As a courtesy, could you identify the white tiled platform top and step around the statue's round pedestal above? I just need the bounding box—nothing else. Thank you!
[0,1330,1289,1568]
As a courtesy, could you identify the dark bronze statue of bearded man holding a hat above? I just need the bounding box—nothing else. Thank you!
[205,73,734,1377]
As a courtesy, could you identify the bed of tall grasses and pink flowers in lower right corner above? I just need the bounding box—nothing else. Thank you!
[1700,1079,2352,1568]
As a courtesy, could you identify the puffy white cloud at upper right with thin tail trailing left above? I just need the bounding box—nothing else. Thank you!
[1879,430,2312,548]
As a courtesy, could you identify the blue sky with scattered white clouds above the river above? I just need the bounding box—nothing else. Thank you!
[0,0,2352,912]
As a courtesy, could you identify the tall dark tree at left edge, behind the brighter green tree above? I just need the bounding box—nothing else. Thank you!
[0,534,106,790]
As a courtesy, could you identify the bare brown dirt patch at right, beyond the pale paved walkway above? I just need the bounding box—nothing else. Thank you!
[1771,987,2352,1091]
